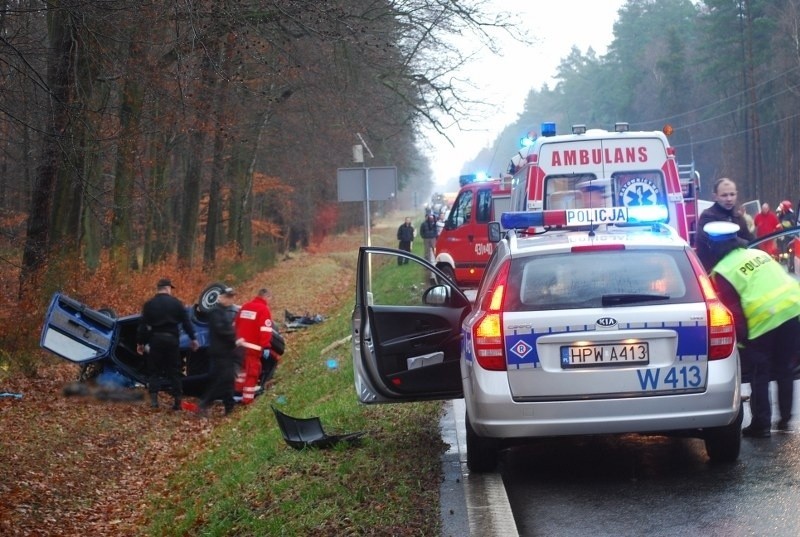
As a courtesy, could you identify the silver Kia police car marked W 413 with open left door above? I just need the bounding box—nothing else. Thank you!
[352,206,743,472]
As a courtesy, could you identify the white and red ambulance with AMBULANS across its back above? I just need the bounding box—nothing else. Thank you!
[509,123,699,244]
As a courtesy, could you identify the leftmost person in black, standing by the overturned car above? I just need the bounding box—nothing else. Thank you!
[136,278,200,410]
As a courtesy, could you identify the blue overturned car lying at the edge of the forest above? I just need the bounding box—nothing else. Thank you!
[39,283,286,397]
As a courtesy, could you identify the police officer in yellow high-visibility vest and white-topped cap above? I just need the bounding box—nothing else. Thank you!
[703,222,800,438]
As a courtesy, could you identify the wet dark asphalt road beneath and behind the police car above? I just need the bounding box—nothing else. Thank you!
[499,382,800,537]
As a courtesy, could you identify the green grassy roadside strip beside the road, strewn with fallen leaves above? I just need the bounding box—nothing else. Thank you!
[143,217,446,536]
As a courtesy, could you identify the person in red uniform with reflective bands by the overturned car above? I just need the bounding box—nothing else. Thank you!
[234,288,272,405]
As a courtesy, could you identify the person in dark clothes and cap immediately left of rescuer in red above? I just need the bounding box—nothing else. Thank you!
[199,287,241,414]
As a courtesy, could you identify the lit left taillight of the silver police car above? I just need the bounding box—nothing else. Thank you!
[472,261,509,371]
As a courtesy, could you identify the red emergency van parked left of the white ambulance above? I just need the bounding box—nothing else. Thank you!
[436,174,511,288]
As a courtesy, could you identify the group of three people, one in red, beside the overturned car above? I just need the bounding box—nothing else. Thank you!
[136,278,275,414]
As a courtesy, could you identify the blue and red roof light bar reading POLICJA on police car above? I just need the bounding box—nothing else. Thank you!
[500,205,669,229]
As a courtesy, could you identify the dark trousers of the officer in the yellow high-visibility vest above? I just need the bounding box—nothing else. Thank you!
[742,318,800,429]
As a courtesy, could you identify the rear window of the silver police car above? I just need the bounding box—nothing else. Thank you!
[505,250,703,311]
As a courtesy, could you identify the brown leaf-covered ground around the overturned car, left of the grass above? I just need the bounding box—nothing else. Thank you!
[0,228,382,536]
